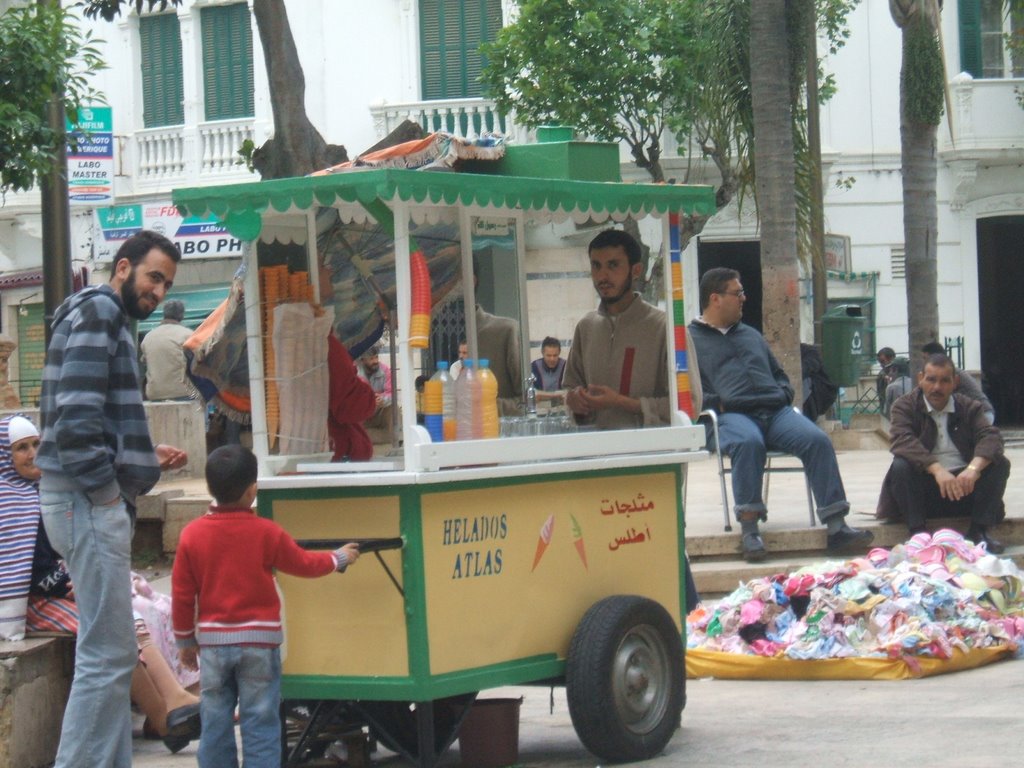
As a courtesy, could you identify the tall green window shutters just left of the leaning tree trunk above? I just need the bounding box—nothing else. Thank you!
[200,3,255,120]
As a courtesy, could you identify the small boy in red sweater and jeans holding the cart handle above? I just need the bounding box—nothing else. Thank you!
[171,445,359,768]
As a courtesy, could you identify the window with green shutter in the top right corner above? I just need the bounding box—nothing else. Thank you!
[958,0,1024,78]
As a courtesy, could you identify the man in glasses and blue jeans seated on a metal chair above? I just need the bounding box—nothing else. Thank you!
[688,267,872,562]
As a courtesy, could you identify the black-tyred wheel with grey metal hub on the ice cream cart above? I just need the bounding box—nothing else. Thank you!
[565,595,686,762]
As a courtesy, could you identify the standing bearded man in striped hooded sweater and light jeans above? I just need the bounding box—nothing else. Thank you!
[36,230,187,768]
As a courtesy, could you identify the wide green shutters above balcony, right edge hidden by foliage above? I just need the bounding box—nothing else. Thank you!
[420,0,502,100]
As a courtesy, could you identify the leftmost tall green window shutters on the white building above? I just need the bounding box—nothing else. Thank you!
[138,13,185,128]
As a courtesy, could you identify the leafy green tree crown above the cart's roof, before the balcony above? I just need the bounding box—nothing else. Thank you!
[480,0,709,178]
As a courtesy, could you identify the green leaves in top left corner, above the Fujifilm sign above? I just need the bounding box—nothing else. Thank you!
[0,3,104,194]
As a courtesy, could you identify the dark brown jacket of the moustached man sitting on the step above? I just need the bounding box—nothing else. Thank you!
[876,387,1006,519]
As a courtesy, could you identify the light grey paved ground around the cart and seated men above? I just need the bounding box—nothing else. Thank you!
[134,449,1024,768]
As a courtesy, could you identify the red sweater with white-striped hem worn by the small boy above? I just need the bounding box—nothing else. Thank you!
[171,507,347,647]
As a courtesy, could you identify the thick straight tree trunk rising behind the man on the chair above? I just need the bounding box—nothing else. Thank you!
[750,0,803,406]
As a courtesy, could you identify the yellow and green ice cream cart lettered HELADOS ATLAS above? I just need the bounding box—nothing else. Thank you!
[174,142,714,766]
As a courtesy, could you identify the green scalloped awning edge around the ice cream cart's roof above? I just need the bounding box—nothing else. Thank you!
[173,169,715,240]
